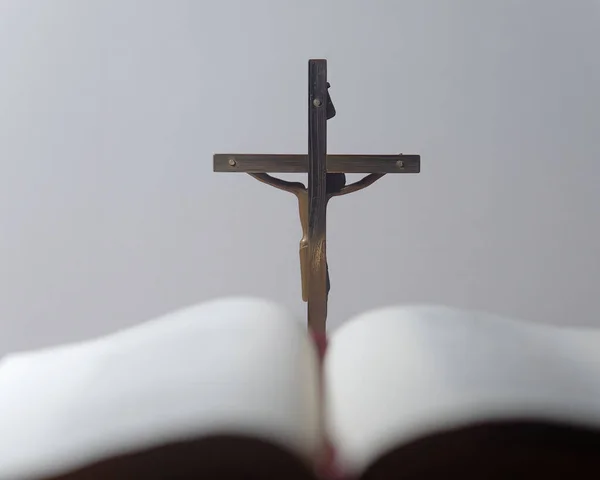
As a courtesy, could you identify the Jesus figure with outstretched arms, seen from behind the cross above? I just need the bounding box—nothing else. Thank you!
[249,173,385,302]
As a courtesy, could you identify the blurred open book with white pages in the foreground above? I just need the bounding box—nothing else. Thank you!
[0,298,600,480]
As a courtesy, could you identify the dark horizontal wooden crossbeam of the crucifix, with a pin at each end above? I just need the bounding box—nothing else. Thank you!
[213,153,421,173]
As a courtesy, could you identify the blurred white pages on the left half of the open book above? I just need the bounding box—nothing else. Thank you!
[0,298,321,480]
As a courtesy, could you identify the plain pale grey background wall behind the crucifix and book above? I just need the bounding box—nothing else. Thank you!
[0,0,600,353]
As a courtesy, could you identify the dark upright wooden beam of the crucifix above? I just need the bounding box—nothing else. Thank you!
[308,60,327,333]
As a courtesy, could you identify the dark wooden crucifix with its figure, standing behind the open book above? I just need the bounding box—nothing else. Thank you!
[213,60,421,334]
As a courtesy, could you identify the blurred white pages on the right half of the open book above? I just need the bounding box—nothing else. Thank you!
[325,307,600,474]
